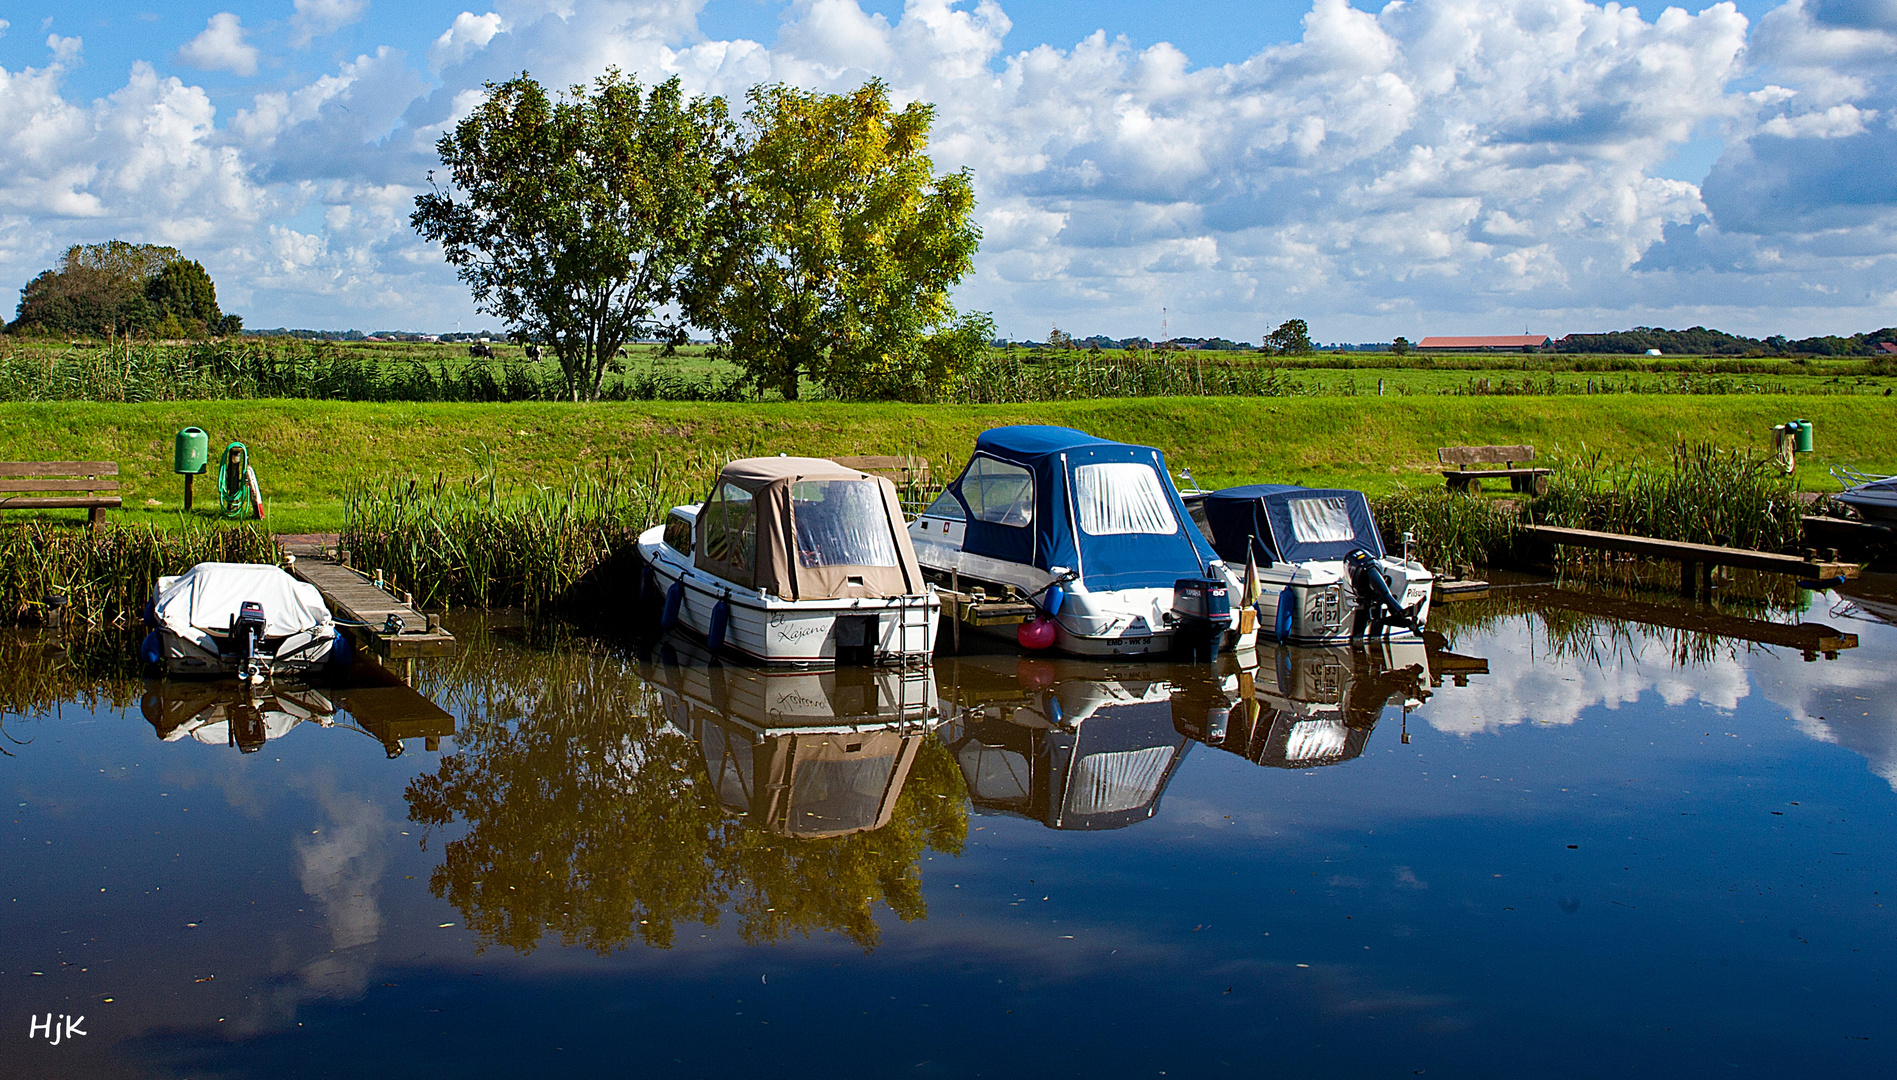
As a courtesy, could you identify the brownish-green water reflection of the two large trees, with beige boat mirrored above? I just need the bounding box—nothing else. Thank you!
[406,630,967,953]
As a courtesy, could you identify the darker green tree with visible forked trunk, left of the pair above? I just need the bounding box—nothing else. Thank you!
[410,70,732,400]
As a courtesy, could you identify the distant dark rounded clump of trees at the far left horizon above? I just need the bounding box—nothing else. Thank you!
[8,239,243,338]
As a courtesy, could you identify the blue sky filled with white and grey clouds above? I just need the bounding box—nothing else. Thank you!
[0,0,1897,340]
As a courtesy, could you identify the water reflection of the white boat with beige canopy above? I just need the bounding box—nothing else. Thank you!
[653,638,939,839]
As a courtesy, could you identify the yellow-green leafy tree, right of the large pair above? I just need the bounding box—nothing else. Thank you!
[687,82,992,399]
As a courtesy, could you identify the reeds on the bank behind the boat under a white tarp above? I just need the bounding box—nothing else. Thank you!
[0,522,281,626]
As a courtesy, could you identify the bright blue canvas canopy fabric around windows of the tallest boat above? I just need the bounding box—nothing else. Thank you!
[949,425,1218,592]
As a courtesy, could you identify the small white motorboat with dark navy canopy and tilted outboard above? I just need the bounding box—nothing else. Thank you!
[1191,484,1436,645]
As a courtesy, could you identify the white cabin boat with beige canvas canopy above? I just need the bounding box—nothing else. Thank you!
[639,449,941,664]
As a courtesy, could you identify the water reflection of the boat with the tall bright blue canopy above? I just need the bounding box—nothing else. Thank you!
[943,657,1205,829]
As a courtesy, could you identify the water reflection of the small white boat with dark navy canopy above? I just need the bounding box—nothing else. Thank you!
[1172,642,1430,769]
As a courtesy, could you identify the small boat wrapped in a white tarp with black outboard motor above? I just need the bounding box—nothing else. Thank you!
[140,562,349,681]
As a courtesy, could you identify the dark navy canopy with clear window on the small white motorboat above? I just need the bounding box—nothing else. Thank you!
[1205,484,1383,566]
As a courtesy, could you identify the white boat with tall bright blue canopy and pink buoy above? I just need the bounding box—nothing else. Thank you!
[909,425,1239,657]
